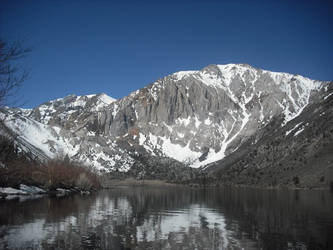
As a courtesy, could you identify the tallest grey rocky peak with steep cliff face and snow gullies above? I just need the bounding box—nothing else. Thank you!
[104,64,323,167]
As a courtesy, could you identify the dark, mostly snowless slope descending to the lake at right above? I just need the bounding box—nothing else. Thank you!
[206,84,333,188]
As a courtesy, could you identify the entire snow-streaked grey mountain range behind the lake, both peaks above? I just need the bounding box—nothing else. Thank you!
[1,64,333,177]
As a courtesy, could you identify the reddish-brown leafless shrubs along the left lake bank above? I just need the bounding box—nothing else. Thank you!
[0,136,100,190]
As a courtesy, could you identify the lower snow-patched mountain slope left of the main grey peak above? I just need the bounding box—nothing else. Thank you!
[1,94,134,171]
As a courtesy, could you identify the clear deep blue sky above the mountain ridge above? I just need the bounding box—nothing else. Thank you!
[0,0,333,107]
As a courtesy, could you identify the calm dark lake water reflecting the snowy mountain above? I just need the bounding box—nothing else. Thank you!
[0,187,333,250]
